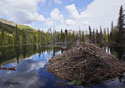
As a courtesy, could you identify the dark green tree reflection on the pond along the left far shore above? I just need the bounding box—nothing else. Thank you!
[0,45,63,65]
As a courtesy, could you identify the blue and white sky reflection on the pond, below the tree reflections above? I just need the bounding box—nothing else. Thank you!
[0,50,125,88]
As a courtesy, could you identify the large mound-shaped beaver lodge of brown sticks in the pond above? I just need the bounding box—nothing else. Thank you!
[47,43,125,84]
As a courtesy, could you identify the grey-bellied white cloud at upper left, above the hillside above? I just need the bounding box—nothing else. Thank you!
[0,0,45,24]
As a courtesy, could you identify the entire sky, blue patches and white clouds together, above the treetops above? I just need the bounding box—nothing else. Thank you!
[0,0,125,30]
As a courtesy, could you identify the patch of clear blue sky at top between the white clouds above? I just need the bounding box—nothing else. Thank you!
[38,0,93,17]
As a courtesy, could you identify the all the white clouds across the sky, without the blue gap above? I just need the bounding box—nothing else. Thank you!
[0,0,125,29]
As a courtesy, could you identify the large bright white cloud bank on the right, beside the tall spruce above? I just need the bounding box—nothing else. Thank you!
[65,0,125,29]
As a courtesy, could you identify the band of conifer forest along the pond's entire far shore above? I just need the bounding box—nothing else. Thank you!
[0,6,125,47]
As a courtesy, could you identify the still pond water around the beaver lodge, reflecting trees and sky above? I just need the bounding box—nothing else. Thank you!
[0,46,125,88]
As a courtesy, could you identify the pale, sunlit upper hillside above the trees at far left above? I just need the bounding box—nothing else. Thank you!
[0,19,35,34]
